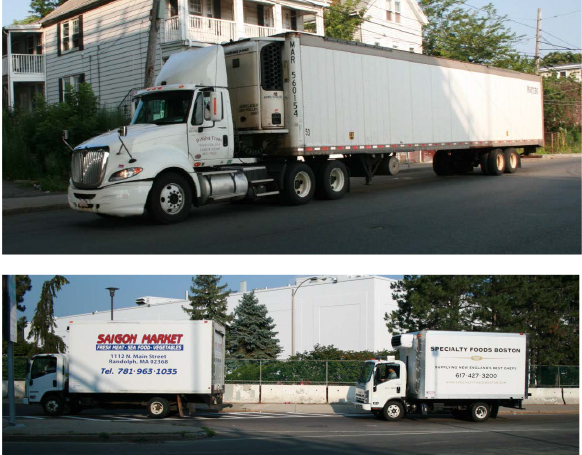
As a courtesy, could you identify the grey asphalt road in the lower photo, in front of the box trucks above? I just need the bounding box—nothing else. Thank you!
[2,413,579,455]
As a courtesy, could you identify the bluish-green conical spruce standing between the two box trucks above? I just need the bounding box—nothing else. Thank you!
[227,291,281,359]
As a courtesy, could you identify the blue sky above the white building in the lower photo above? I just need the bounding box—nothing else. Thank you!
[18,275,402,321]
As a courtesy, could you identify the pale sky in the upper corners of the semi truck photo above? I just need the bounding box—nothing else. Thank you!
[2,0,582,55]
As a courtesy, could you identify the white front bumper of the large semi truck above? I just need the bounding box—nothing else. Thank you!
[68,180,153,217]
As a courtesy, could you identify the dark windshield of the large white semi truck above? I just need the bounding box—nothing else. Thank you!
[131,90,193,125]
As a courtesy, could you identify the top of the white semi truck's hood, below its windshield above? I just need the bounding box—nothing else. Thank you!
[75,123,186,151]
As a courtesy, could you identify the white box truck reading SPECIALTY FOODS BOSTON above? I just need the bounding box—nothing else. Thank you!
[354,330,528,422]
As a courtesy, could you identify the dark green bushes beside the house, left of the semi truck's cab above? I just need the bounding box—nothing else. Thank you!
[2,83,129,184]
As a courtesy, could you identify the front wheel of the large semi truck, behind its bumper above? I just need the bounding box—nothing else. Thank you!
[148,172,192,224]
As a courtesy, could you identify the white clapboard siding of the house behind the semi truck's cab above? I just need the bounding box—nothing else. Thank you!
[44,0,161,108]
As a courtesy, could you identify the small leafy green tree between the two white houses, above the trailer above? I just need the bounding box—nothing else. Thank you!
[323,0,366,41]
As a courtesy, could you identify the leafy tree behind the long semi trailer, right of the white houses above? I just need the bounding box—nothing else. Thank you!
[419,0,522,66]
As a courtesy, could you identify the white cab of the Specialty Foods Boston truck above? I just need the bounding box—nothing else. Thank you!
[354,357,407,420]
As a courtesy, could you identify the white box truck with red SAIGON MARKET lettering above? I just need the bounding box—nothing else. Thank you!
[24,321,225,418]
